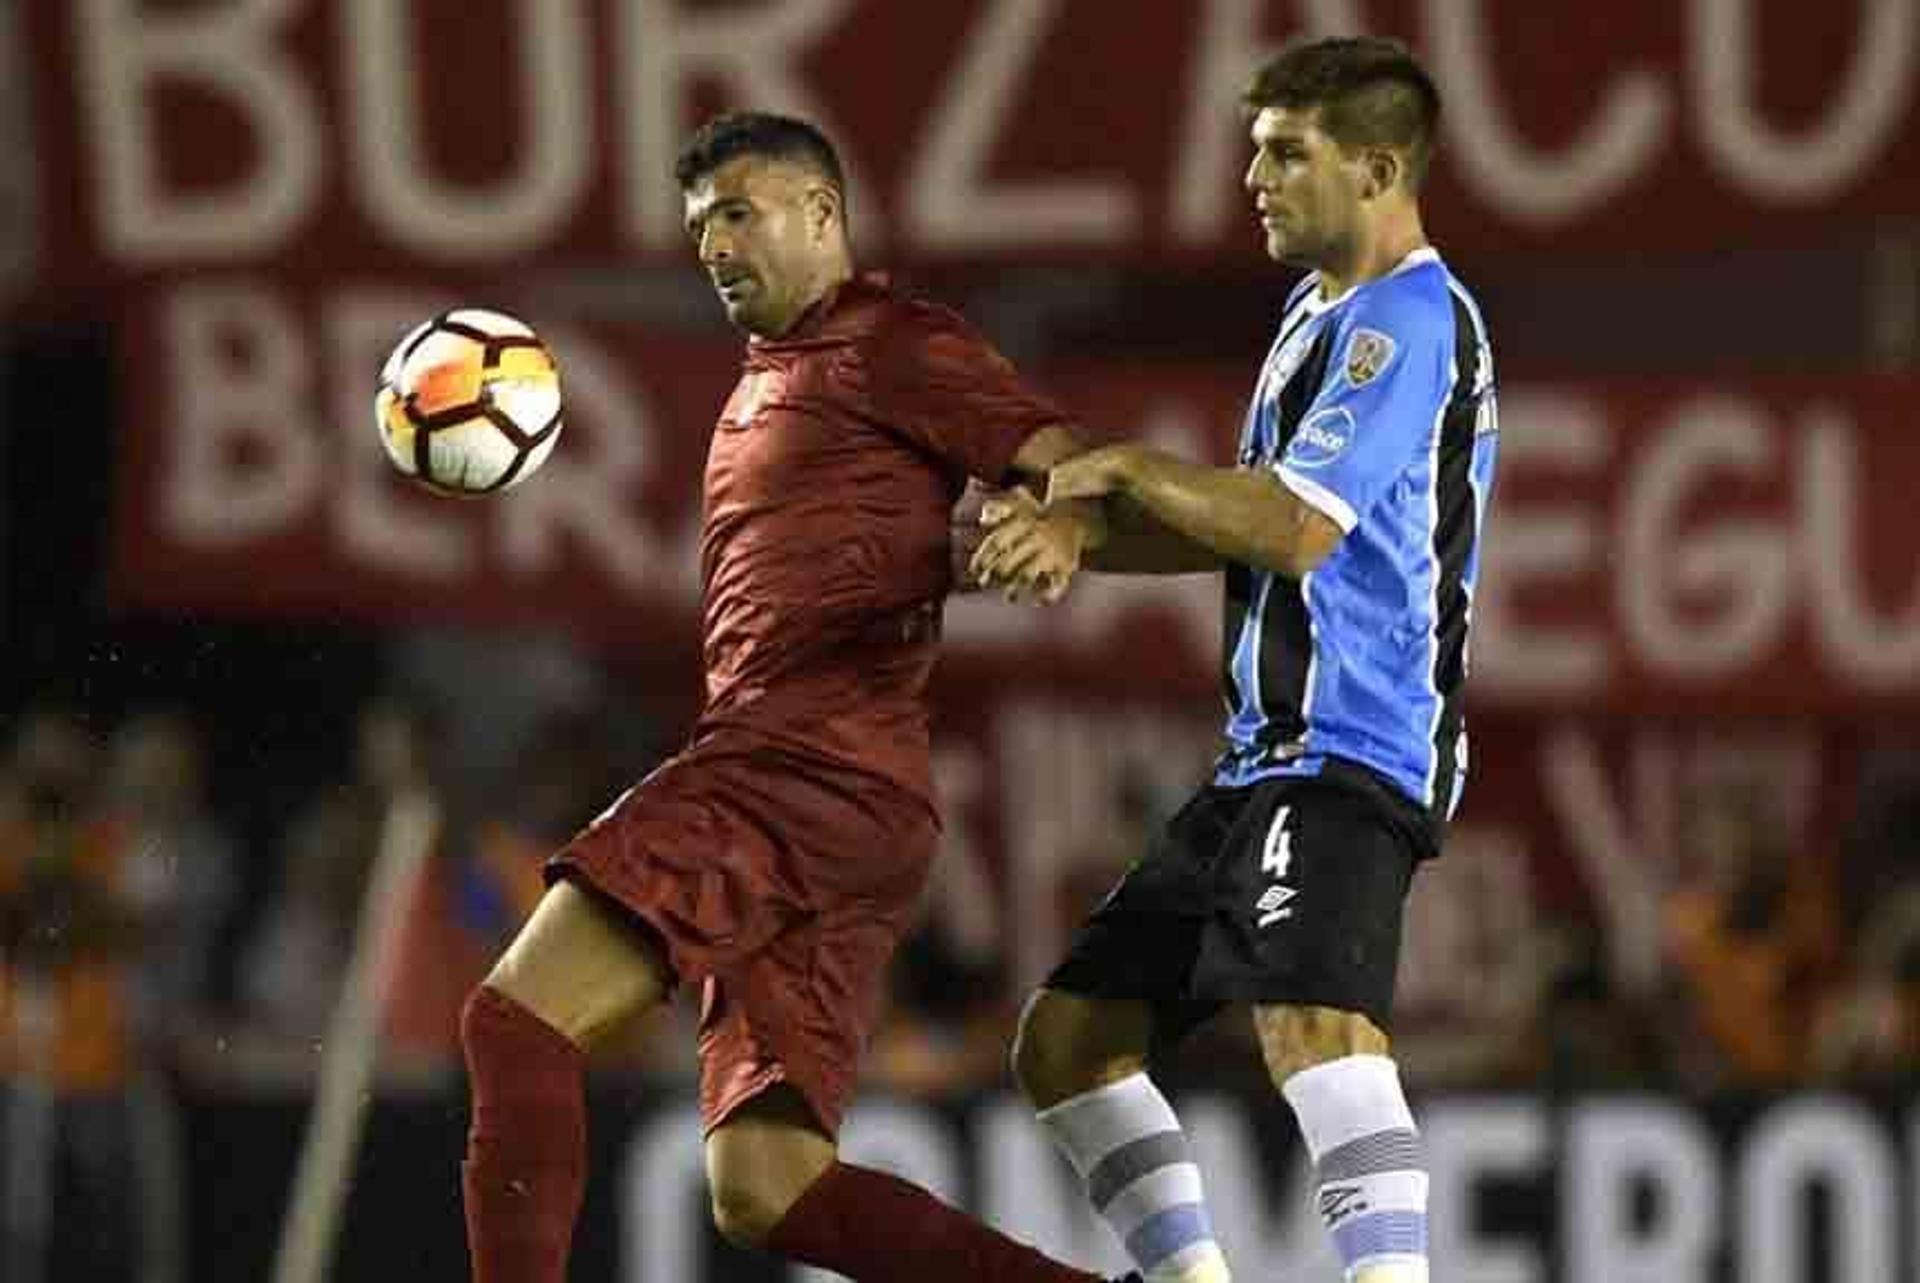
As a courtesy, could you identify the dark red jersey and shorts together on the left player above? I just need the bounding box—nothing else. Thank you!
[549,277,1064,1131]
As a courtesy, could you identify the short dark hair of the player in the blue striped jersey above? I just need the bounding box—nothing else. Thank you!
[1240,36,1440,188]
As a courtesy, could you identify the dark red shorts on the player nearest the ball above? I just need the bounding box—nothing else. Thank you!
[547,741,939,1131]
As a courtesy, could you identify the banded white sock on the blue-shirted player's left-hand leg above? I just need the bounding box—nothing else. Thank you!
[1039,1074,1233,1283]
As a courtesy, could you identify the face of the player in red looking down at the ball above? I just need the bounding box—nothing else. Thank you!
[685,156,843,338]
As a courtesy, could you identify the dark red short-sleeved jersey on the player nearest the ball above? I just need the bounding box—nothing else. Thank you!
[695,275,1066,807]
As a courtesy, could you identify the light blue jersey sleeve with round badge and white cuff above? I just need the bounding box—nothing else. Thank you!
[1275,290,1453,532]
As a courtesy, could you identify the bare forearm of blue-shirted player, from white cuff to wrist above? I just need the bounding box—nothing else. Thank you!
[1117,449,1317,576]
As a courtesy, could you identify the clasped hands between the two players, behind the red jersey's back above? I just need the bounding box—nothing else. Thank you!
[968,446,1133,605]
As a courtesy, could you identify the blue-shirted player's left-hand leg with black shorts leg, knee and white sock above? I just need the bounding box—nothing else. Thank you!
[1014,789,1238,1283]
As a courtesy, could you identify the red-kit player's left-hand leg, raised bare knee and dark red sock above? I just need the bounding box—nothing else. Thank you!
[461,882,672,1283]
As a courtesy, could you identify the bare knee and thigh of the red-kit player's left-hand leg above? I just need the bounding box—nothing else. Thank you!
[486,880,672,1047]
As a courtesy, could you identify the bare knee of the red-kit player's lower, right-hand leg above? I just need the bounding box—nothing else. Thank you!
[707,1085,837,1245]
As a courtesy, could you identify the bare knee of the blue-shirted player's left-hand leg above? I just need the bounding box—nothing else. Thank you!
[1014,987,1154,1110]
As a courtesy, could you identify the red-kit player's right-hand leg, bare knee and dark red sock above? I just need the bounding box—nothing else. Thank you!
[707,1085,1100,1283]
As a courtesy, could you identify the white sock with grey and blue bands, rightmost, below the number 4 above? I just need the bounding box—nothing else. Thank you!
[1281,1056,1427,1283]
